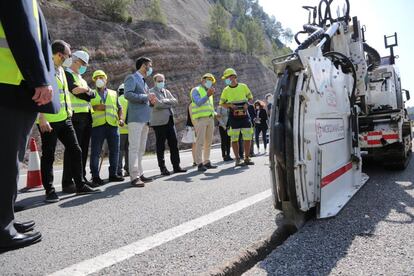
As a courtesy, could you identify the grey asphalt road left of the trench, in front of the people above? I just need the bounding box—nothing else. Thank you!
[0,146,277,275]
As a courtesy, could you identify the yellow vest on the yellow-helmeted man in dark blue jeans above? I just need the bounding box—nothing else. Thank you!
[91,89,119,127]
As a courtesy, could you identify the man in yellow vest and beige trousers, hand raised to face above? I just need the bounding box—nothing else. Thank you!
[190,73,217,172]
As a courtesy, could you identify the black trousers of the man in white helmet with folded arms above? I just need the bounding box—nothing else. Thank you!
[62,113,92,186]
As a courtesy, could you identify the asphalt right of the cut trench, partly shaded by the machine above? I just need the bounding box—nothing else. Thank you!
[244,158,414,276]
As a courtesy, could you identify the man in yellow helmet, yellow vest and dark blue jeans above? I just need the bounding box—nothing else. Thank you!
[90,70,124,186]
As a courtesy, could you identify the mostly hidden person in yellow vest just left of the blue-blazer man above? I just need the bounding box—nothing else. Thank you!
[117,83,129,176]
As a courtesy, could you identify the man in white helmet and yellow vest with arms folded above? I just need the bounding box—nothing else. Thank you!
[62,51,97,187]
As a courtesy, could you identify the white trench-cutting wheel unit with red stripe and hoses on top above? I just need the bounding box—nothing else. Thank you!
[269,0,410,227]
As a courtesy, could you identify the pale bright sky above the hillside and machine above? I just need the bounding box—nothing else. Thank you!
[259,0,414,106]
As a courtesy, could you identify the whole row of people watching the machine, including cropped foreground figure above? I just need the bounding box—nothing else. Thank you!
[0,0,268,251]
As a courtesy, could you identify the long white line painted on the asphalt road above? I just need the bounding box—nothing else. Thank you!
[50,189,271,276]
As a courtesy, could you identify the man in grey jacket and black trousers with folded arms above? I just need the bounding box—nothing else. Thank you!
[150,74,187,175]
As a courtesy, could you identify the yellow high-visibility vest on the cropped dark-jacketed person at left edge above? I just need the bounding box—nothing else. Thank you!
[0,0,41,85]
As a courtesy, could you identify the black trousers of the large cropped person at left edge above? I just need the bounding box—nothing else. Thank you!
[0,107,37,244]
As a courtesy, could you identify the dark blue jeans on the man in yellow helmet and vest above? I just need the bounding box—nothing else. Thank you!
[90,124,119,177]
